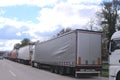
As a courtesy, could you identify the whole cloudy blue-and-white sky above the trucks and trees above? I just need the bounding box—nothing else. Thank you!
[0,0,102,51]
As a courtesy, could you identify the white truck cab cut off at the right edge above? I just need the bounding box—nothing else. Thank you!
[109,31,120,80]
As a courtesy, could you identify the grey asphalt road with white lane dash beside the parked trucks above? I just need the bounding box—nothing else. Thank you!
[0,59,108,80]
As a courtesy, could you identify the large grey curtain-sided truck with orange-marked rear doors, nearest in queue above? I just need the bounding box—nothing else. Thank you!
[31,29,101,77]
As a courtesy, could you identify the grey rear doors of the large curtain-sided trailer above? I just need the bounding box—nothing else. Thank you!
[77,32,101,65]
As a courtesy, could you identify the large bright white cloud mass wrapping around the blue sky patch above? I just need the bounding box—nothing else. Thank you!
[0,0,101,33]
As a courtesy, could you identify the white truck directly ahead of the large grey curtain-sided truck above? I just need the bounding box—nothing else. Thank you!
[17,45,33,64]
